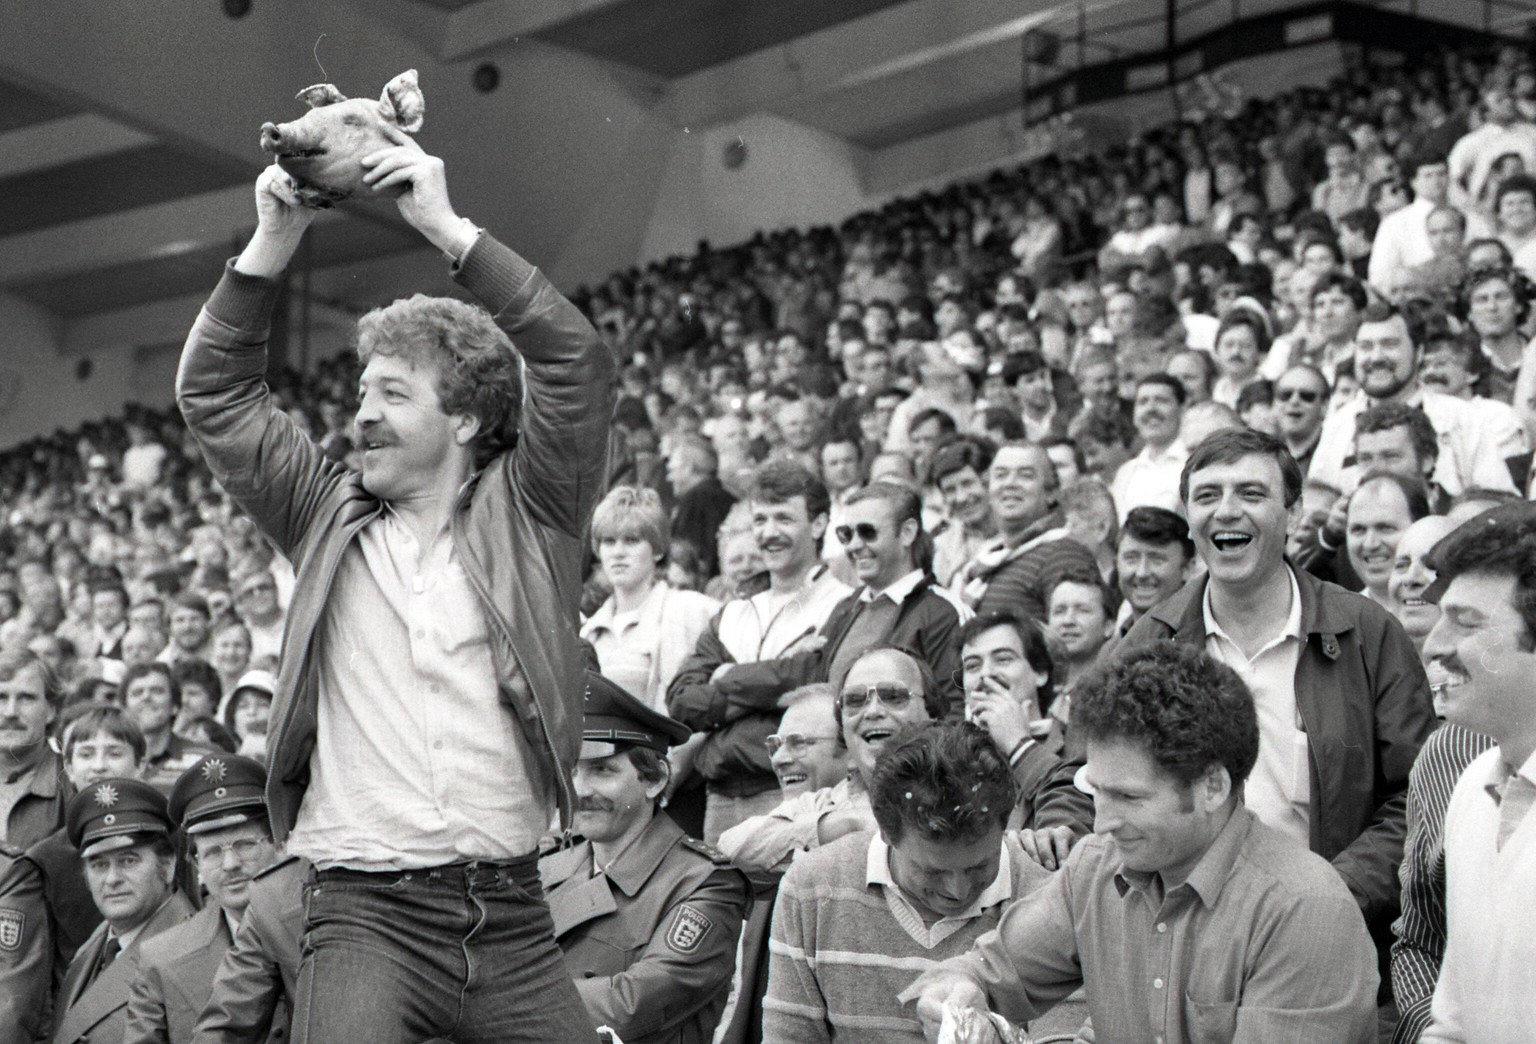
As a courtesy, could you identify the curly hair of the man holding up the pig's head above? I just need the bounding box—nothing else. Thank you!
[356,293,525,467]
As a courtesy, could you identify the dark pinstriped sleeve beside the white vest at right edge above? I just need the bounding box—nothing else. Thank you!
[1392,723,1493,1044]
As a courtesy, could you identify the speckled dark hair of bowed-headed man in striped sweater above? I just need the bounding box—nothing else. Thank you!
[869,722,1018,844]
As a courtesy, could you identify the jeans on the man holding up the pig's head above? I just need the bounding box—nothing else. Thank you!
[293,855,598,1044]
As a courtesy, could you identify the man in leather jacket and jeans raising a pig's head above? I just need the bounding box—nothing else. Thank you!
[177,140,614,1044]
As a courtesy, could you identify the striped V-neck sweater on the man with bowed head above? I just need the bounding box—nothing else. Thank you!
[763,834,1051,1044]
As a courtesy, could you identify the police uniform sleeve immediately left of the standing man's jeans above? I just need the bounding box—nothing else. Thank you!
[195,855,309,1044]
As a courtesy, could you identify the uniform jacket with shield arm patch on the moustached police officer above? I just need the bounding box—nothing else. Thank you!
[539,815,751,1044]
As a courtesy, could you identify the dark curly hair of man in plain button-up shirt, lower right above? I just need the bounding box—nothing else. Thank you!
[1072,642,1258,791]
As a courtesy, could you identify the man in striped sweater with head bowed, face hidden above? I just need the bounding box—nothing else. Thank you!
[763,721,1049,1044]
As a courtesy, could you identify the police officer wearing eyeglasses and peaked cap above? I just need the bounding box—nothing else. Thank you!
[123,754,283,1044]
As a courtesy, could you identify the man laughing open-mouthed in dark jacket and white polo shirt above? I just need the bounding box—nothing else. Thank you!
[1121,430,1435,1025]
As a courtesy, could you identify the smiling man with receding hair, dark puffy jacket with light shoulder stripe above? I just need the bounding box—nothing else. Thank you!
[940,444,1098,620]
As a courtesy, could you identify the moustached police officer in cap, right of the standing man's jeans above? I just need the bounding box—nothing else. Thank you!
[539,671,751,1044]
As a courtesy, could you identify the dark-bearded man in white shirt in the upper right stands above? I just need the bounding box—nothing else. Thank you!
[1307,306,1525,511]
